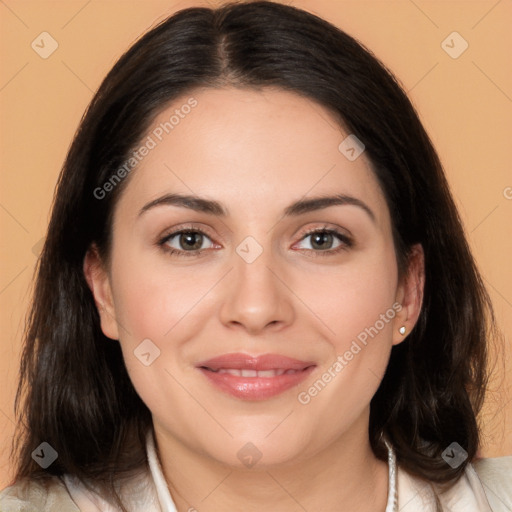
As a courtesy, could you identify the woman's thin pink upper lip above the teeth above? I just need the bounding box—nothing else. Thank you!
[197,353,315,371]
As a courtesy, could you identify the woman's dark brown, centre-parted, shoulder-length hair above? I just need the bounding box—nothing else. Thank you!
[13,1,495,508]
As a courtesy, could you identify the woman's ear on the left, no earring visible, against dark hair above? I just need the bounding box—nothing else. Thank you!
[83,245,119,340]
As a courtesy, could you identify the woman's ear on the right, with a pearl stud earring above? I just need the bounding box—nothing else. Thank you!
[393,244,425,345]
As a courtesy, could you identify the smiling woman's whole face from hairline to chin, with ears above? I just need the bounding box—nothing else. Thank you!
[84,89,421,466]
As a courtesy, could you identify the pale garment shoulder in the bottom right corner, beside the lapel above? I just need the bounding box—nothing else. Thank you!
[472,456,512,512]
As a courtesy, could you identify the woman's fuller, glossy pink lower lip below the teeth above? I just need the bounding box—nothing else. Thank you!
[198,366,315,400]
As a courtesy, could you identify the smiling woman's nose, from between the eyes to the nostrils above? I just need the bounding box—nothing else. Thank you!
[220,242,294,335]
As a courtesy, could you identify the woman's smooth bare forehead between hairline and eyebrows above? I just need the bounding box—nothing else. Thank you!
[115,88,387,226]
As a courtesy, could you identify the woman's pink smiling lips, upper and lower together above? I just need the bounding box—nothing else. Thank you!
[196,353,316,400]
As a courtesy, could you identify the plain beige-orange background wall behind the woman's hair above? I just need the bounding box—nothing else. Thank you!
[0,0,512,488]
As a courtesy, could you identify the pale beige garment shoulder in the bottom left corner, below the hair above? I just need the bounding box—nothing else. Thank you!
[0,477,80,512]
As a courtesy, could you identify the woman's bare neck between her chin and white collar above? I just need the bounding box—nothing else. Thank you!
[155,414,388,512]
